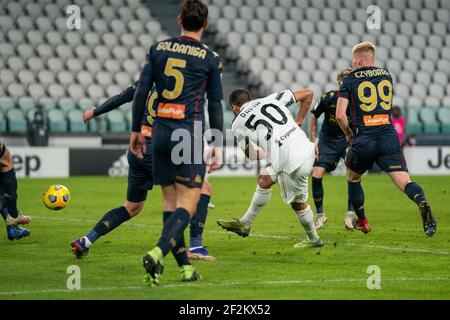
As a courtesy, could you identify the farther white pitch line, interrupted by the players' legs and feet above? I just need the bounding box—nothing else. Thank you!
[31,216,450,256]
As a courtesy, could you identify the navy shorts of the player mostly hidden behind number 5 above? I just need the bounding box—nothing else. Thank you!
[127,142,153,202]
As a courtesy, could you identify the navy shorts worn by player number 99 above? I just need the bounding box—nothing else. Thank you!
[345,130,408,174]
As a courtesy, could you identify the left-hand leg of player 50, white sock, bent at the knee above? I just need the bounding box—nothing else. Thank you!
[217,171,276,238]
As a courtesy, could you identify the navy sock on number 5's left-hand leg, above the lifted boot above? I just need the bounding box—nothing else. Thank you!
[157,208,191,256]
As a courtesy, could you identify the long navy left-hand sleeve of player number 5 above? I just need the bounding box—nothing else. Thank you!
[131,46,154,132]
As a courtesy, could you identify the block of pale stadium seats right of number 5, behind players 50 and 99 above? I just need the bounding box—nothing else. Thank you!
[207,0,450,133]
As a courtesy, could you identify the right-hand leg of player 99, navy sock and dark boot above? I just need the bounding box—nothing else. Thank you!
[389,171,437,237]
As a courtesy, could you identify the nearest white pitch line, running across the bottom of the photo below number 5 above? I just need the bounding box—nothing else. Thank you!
[0,276,450,296]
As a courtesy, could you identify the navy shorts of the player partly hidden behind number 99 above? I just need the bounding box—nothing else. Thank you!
[314,136,348,172]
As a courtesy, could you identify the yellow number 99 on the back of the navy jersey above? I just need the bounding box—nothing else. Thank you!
[358,80,392,112]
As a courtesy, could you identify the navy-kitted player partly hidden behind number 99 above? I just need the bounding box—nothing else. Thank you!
[309,68,354,230]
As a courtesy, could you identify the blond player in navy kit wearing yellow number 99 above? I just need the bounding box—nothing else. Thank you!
[336,42,436,237]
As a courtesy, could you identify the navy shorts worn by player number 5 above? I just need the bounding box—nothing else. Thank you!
[152,122,206,188]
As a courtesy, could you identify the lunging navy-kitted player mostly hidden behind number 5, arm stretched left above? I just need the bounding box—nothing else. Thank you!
[71,82,215,260]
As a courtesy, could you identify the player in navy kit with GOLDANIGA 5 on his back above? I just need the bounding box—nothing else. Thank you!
[130,0,223,284]
